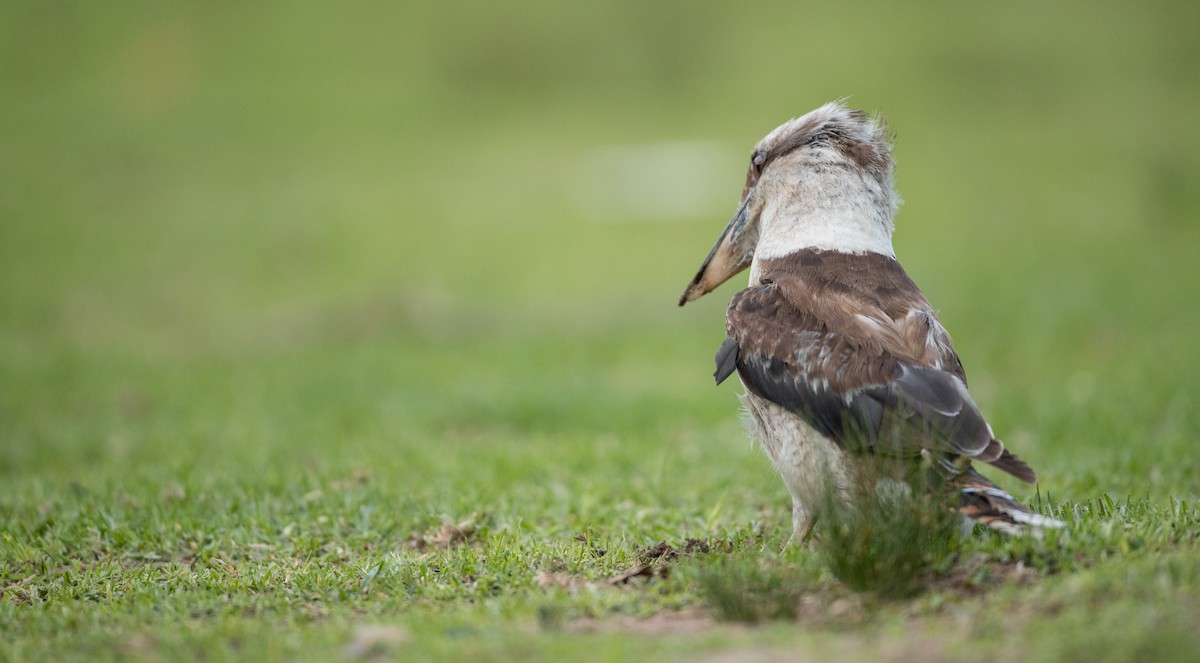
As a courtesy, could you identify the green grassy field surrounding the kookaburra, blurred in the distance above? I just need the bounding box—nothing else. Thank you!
[0,2,1200,661]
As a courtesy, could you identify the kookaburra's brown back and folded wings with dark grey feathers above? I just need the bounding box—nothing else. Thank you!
[715,256,1036,482]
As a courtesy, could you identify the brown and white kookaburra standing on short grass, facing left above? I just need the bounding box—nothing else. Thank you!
[679,102,1062,540]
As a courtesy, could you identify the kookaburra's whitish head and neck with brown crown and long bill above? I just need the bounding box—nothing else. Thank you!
[679,101,900,306]
